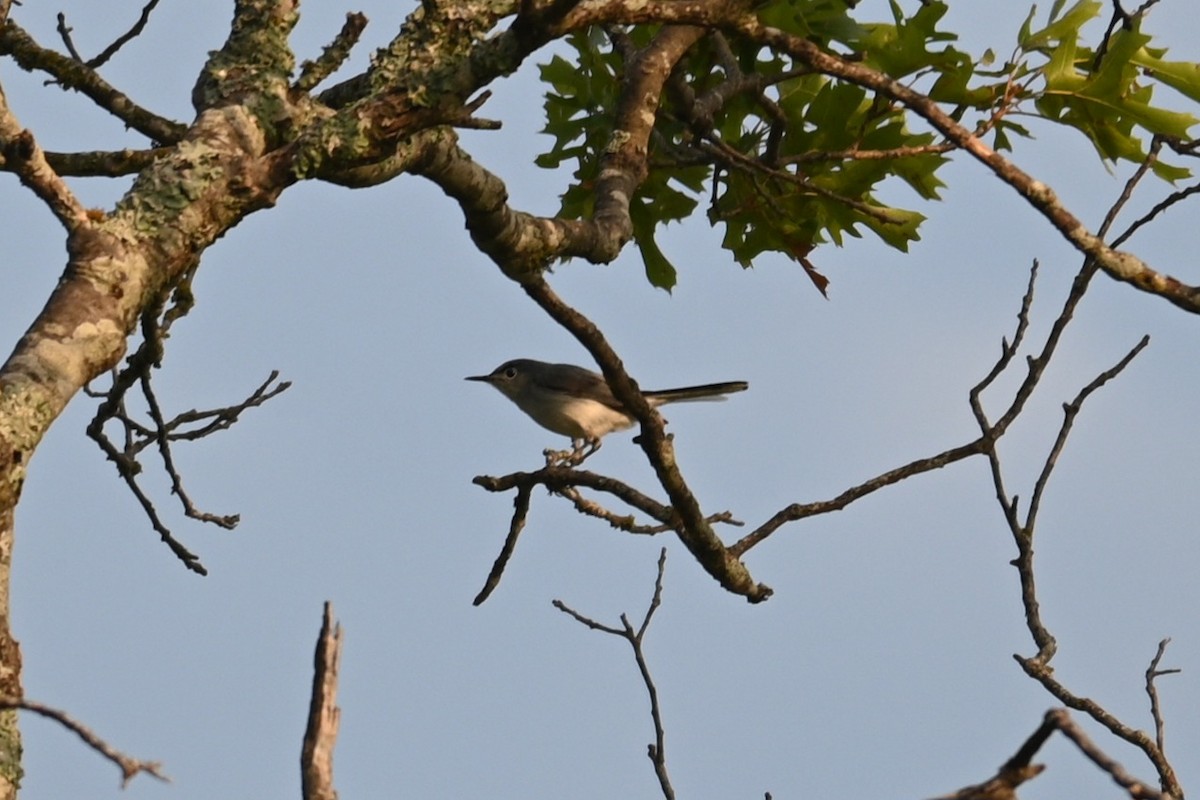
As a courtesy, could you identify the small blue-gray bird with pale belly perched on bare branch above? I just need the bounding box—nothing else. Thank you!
[467,359,750,450]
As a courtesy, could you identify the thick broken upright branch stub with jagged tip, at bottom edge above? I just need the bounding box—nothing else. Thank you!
[300,602,342,800]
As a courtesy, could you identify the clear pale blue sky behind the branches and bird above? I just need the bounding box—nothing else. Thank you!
[0,0,1200,800]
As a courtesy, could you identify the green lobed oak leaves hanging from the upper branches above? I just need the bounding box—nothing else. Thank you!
[538,0,1200,289]
